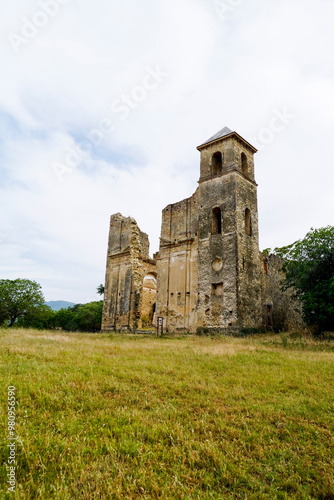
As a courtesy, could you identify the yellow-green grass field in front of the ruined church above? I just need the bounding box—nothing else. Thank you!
[0,330,334,500]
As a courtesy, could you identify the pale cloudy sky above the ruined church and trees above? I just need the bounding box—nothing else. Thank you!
[0,0,334,303]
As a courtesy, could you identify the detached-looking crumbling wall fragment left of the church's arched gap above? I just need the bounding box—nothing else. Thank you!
[102,213,156,330]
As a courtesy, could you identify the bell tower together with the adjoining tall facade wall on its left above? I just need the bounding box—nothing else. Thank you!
[157,131,261,332]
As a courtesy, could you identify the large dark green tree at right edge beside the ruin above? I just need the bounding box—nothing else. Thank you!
[275,226,334,332]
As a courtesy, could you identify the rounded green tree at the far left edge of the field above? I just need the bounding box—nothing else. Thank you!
[0,279,45,327]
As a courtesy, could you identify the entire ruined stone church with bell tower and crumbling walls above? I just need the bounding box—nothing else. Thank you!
[102,127,300,333]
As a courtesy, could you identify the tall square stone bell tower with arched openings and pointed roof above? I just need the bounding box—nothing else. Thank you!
[197,127,261,331]
